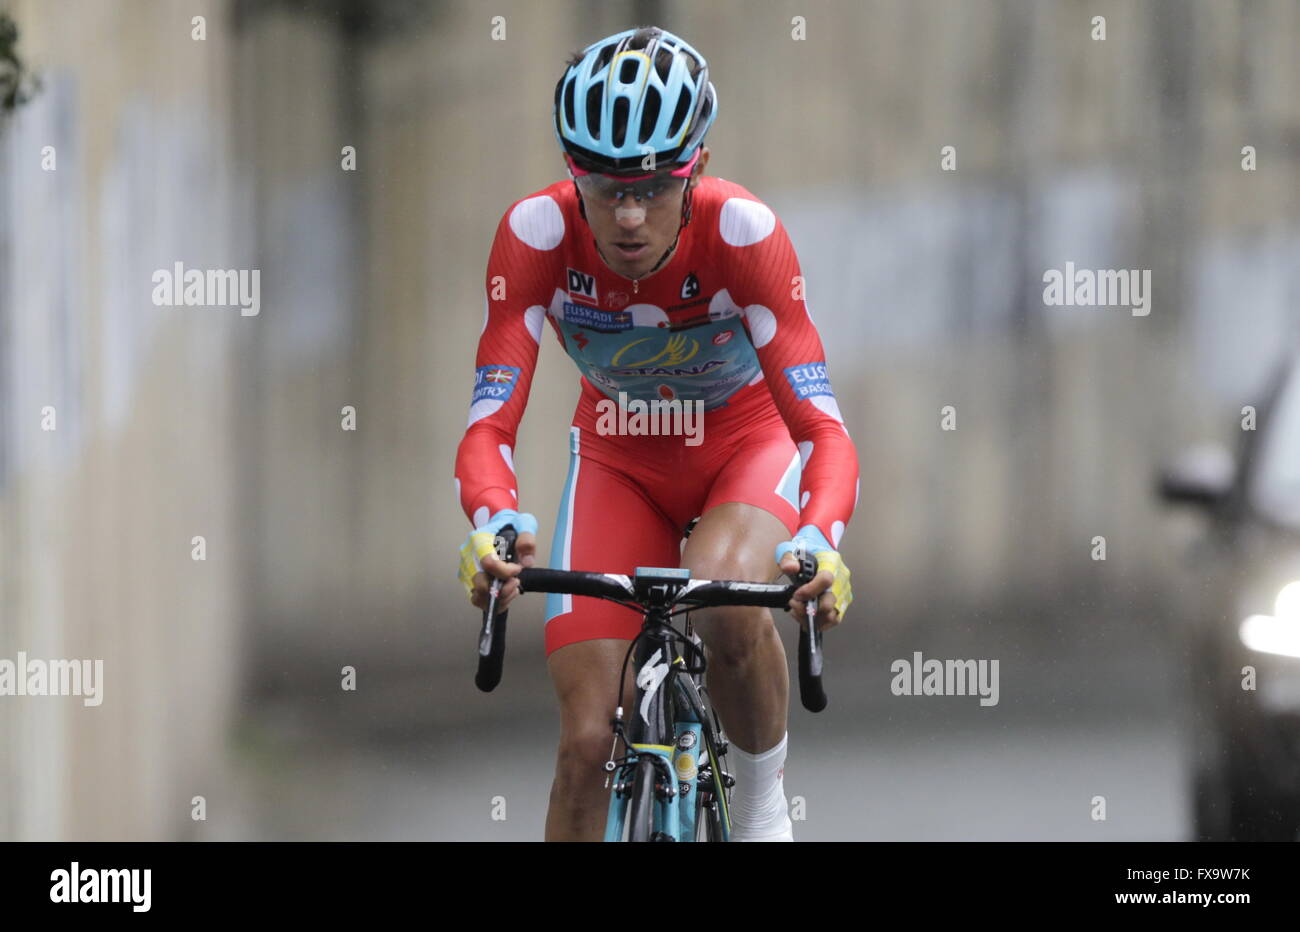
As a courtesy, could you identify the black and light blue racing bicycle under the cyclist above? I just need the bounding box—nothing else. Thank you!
[475,526,827,842]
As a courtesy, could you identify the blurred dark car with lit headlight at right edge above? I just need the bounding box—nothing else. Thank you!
[1160,351,1300,841]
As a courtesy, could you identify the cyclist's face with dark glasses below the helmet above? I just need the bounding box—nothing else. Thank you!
[582,147,709,278]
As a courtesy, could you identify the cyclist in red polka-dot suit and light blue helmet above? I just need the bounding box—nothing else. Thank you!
[455,27,858,841]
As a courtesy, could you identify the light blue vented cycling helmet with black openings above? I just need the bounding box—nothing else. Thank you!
[555,26,718,173]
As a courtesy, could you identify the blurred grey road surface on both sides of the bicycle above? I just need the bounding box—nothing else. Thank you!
[220,613,1190,841]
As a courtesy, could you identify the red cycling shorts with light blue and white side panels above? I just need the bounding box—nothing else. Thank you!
[546,380,800,655]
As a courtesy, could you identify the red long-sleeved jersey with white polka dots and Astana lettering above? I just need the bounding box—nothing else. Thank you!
[455,177,858,546]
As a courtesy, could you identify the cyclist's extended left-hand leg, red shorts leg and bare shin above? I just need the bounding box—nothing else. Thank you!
[546,428,681,841]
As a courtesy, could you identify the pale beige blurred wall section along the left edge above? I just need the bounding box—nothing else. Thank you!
[0,0,250,840]
